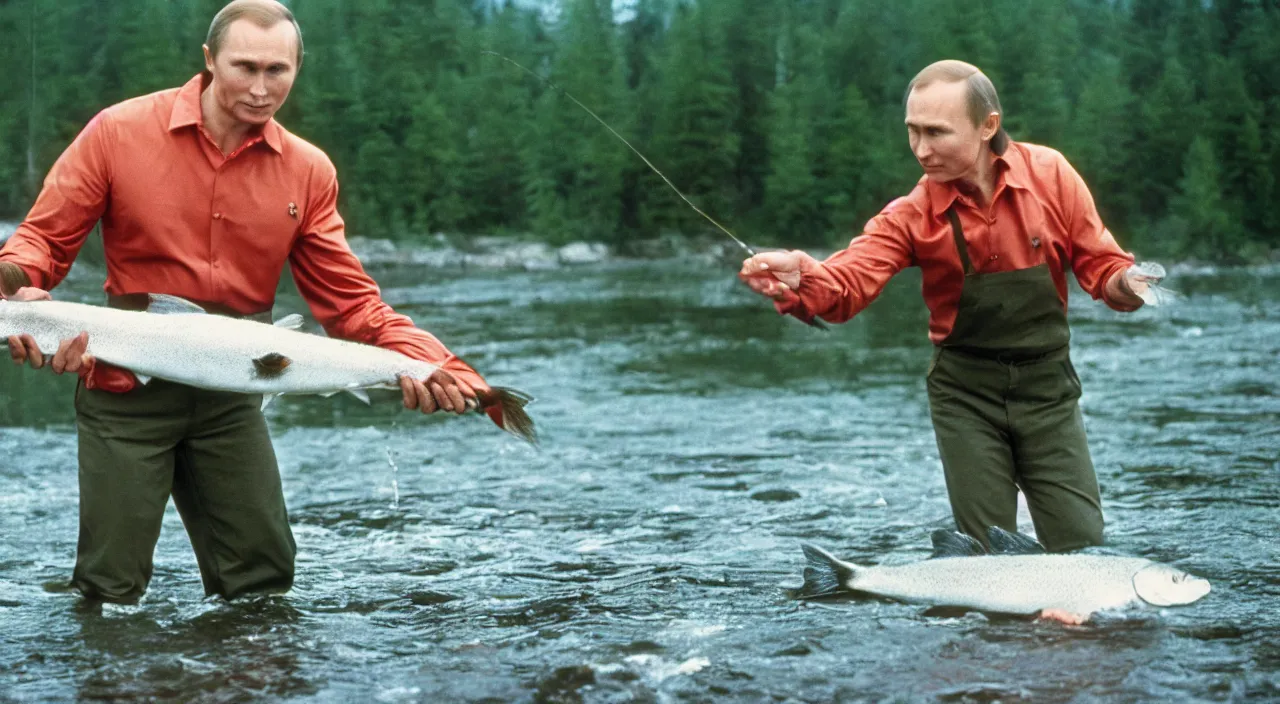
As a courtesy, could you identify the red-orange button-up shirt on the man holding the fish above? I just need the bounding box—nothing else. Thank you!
[0,76,488,399]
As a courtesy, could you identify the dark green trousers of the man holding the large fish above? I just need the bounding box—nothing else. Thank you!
[73,379,296,602]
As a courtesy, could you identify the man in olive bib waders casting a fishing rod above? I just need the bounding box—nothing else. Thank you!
[739,60,1158,552]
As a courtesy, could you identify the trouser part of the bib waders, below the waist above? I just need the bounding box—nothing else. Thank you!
[928,347,1102,552]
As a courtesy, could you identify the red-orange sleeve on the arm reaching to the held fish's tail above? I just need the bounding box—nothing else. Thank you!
[289,164,488,390]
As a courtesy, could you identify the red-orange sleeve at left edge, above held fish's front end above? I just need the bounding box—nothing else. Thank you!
[0,111,114,291]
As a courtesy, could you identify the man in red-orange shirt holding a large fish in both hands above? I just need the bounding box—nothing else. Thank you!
[0,0,502,602]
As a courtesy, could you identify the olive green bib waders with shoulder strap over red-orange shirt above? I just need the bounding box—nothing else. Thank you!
[928,210,1102,552]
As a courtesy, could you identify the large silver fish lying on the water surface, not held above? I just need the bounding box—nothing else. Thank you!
[797,527,1210,617]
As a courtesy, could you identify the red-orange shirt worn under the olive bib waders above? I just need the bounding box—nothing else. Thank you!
[776,142,1134,344]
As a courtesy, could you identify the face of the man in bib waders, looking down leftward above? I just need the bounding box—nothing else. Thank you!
[906,81,1000,183]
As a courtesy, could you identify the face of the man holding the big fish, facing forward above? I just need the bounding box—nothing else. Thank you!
[205,19,298,125]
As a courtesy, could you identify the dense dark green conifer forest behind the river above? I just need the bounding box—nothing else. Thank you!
[0,0,1280,261]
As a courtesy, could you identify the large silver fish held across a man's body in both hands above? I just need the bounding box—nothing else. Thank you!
[0,296,536,443]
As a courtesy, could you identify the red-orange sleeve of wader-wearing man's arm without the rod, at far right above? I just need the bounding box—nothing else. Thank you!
[1059,157,1134,311]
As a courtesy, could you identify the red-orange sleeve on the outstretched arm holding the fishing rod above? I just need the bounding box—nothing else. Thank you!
[776,202,914,323]
